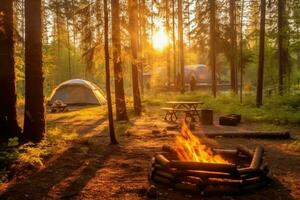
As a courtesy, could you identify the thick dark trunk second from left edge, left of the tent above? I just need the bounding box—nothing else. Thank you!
[24,0,45,142]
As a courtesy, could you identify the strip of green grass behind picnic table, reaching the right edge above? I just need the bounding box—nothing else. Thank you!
[144,92,300,126]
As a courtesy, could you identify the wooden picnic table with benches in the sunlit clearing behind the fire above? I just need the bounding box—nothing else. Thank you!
[161,101,203,122]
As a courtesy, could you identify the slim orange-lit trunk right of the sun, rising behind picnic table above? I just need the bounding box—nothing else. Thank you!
[178,0,185,94]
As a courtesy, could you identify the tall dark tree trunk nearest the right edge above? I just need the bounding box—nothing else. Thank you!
[278,0,289,95]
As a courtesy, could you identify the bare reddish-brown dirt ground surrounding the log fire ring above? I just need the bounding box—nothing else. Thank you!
[0,105,300,200]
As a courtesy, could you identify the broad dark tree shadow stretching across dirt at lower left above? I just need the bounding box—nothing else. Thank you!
[0,116,127,199]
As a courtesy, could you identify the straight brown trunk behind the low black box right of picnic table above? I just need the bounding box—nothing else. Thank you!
[229,0,237,93]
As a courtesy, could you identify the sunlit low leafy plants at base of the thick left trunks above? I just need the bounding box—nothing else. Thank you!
[0,127,78,183]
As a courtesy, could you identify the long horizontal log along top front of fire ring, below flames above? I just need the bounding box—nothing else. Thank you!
[168,161,237,174]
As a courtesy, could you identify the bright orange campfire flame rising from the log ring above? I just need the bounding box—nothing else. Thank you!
[175,122,228,163]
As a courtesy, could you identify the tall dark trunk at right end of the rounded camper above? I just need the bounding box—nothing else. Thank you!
[209,1,217,97]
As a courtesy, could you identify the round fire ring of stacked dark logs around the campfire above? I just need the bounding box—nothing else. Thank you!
[149,145,270,195]
